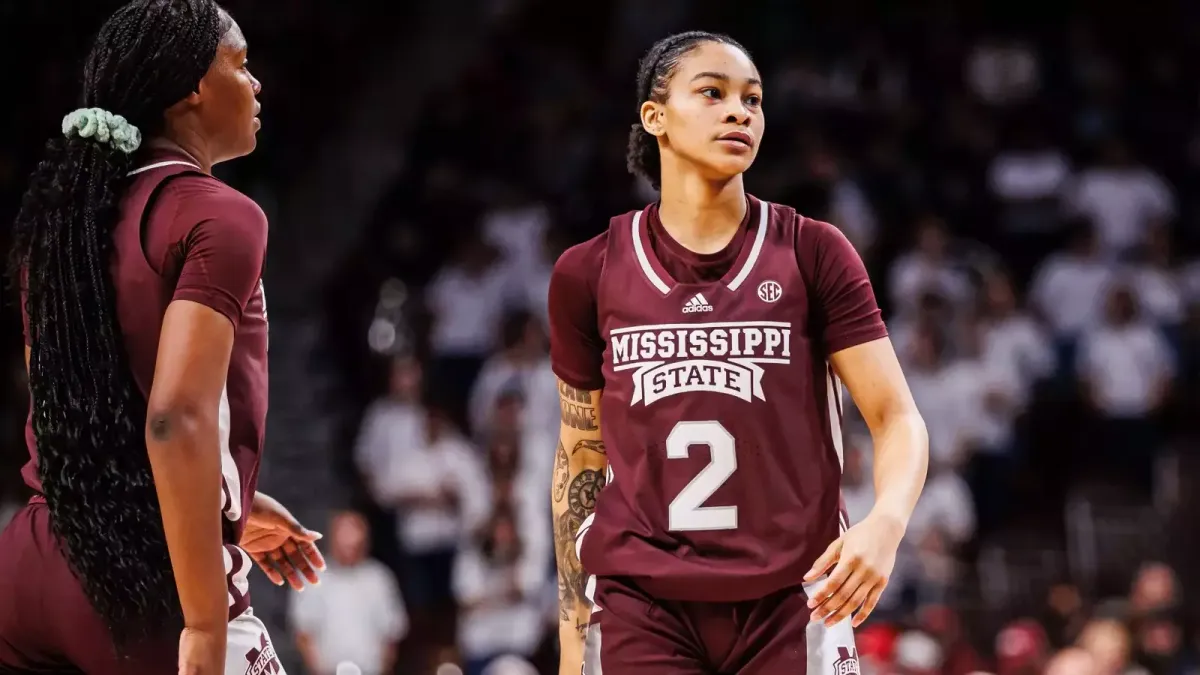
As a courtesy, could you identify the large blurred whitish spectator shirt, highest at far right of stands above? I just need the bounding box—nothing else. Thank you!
[1068,167,1175,253]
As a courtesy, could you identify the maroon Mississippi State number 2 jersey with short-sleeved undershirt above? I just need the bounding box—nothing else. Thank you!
[550,197,887,602]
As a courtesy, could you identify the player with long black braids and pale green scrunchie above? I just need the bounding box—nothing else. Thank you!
[0,0,322,675]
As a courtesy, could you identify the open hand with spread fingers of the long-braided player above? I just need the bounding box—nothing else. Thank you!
[240,492,325,591]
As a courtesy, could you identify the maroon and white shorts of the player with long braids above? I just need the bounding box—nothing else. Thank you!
[0,503,286,675]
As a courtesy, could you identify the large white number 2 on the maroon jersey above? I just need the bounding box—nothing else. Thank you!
[667,422,738,532]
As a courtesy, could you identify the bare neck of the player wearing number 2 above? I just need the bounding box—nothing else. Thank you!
[659,172,746,253]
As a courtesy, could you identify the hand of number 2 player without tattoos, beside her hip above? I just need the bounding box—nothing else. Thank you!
[804,513,904,628]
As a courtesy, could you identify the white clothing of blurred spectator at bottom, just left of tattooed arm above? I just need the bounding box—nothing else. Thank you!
[454,525,548,658]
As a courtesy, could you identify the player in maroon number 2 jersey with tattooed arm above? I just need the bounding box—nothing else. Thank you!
[550,32,928,675]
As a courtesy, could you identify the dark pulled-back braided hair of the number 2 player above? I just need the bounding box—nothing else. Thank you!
[625,30,750,190]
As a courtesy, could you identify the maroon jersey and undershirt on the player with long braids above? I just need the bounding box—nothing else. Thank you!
[22,151,266,619]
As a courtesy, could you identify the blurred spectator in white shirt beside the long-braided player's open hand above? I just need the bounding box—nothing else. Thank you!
[290,512,408,675]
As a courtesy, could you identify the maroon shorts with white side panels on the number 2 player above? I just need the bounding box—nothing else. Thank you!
[583,578,858,675]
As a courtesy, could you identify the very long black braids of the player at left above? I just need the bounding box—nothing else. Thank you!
[8,0,233,651]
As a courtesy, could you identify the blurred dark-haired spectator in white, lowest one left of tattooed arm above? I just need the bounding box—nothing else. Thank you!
[454,507,547,675]
